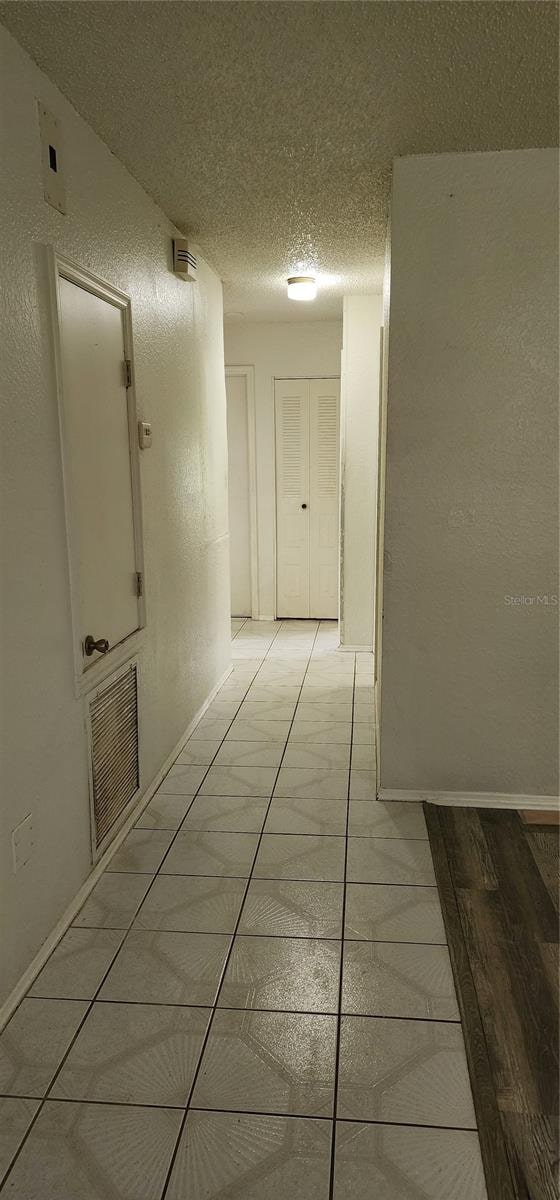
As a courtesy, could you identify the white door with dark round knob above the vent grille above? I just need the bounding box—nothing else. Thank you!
[59,276,140,670]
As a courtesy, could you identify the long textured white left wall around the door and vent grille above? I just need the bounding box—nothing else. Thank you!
[0,32,229,994]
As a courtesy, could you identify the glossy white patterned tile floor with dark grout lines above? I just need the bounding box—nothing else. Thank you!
[0,619,486,1200]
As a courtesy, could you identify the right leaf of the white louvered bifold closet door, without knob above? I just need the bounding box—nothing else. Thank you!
[309,379,341,620]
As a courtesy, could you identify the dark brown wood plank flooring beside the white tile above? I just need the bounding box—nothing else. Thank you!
[424,804,560,1200]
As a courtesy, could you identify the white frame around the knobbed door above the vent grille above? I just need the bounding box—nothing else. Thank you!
[47,246,146,696]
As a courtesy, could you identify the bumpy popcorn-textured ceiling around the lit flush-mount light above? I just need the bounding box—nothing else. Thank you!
[0,0,558,320]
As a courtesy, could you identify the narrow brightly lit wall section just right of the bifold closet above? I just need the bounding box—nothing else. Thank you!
[341,295,383,649]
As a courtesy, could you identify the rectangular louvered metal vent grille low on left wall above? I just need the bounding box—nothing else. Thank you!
[90,664,140,848]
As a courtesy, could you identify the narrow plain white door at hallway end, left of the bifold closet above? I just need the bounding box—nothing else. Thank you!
[225,374,252,617]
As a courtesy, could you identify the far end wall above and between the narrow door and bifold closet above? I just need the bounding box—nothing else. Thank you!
[225,320,342,617]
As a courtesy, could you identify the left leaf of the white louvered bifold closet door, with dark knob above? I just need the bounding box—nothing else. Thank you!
[275,379,309,617]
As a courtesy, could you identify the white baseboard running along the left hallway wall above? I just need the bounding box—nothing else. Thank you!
[0,665,233,1031]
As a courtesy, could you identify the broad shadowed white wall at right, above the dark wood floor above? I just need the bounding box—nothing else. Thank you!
[380,150,559,796]
